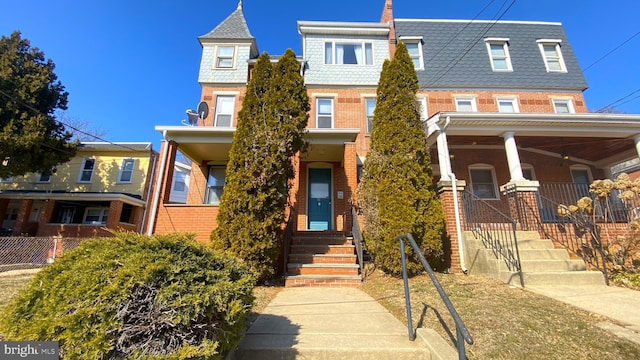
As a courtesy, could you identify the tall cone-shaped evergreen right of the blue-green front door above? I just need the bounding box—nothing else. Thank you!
[357,43,444,274]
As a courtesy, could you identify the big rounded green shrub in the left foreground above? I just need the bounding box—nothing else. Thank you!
[0,233,255,359]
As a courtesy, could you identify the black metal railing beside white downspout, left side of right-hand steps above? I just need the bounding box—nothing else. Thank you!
[461,190,524,287]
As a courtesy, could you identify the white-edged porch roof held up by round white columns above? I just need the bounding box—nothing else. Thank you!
[425,112,640,167]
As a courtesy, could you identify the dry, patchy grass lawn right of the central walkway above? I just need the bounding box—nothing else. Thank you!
[362,269,640,359]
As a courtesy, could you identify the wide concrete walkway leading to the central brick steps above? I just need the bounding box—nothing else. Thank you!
[232,287,457,360]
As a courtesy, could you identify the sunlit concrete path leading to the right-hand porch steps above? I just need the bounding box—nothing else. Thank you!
[525,285,640,344]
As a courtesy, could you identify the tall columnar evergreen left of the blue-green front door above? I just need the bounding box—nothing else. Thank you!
[211,50,309,279]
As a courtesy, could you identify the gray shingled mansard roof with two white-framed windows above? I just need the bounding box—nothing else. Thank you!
[395,19,587,91]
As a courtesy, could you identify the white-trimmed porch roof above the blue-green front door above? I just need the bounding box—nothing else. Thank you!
[155,126,360,163]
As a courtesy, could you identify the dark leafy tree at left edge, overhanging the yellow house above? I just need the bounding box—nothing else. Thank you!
[0,31,76,178]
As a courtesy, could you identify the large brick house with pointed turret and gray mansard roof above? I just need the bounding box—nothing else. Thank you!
[149,0,640,283]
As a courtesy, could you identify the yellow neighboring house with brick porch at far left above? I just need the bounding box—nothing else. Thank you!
[0,142,157,237]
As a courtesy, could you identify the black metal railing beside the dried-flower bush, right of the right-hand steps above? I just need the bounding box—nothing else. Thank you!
[513,192,609,285]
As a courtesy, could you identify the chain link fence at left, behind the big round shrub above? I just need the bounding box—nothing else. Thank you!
[0,236,86,273]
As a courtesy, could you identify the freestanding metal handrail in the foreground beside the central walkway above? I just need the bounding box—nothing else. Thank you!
[396,234,473,360]
